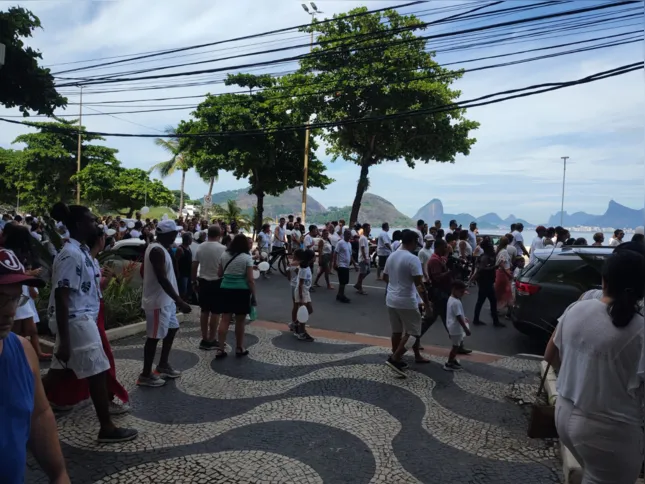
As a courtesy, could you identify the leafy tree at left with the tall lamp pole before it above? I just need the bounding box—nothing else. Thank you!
[12,118,119,212]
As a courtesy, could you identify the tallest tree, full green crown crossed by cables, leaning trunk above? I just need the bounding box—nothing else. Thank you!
[292,7,479,224]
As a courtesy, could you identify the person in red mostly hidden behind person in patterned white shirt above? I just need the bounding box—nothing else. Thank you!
[47,228,130,415]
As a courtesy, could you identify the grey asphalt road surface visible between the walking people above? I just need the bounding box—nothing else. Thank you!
[256,269,545,356]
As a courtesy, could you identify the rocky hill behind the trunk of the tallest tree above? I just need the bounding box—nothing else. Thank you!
[307,193,416,228]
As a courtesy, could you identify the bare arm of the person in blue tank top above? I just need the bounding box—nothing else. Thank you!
[20,338,70,484]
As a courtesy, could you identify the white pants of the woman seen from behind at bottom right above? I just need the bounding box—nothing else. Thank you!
[555,397,643,484]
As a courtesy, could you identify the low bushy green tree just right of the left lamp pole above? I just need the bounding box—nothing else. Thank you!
[74,163,174,217]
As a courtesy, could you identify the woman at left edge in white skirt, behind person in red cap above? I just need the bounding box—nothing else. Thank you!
[0,223,52,361]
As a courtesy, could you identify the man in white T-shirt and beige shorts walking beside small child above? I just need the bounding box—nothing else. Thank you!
[383,230,430,377]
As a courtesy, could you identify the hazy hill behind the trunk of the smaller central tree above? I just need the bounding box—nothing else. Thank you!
[208,188,327,218]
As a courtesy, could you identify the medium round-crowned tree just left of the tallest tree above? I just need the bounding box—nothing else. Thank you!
[180,74,333,230]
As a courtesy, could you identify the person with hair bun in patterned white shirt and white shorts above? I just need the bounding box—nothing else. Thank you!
[43,202,138,443]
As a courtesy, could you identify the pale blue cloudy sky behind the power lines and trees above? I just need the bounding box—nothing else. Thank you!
[0,0,645,223]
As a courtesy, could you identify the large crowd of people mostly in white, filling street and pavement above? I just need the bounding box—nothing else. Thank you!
[0,203,645,483]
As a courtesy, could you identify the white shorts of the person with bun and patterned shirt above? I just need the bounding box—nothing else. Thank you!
[51,315,110,379]
